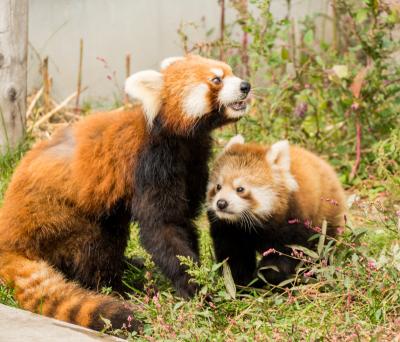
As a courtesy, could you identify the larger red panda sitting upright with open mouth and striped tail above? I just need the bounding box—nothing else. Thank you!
[0,56,250,330]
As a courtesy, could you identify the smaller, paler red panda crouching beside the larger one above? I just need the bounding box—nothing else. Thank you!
[207,135,345,285]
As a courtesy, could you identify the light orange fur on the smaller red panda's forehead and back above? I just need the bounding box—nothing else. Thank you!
[208,143,346,235]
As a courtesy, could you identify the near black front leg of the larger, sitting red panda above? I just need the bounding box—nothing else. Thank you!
[132,139,199,298]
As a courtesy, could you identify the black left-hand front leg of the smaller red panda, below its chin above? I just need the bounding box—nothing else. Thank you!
[208,213,256,286]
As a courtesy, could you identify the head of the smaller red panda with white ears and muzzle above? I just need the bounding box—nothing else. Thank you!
[207,135,298,225]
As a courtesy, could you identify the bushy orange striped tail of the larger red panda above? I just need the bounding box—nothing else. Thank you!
[0,252,141,331]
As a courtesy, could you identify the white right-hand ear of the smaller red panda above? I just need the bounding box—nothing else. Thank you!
[266,140,299,192]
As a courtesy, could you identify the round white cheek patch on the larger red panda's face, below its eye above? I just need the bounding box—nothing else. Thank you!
[183,83,211,117]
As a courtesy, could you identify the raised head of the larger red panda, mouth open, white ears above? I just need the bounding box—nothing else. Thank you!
[125,55,250,134]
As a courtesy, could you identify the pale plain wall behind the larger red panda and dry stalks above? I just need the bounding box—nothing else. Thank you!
[28,0,327,101]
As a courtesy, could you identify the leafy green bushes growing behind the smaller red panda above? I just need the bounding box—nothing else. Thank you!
[180,0,400,184]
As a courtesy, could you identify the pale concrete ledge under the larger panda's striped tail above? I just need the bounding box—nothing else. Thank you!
[0,304,124,342]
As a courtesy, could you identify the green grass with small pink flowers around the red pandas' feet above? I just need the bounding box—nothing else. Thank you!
[0,136,400,341]
